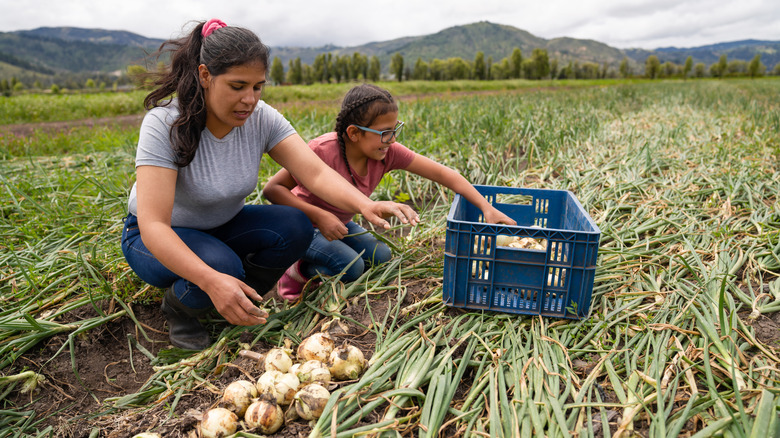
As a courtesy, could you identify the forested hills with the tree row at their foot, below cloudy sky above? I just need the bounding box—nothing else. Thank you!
[0,21,780,94]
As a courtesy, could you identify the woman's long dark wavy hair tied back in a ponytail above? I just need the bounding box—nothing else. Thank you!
[144,18,270,167]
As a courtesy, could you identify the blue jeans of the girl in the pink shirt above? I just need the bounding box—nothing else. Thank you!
[301,221,393,283]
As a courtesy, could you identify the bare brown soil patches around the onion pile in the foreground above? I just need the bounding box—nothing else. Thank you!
[11,279,432,438]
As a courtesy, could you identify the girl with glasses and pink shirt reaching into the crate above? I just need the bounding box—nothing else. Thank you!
[263,84,516,299]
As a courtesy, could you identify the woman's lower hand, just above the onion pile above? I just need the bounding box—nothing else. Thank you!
[203,273,268,325]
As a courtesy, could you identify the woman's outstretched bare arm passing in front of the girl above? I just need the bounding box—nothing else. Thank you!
[268,134,419,228]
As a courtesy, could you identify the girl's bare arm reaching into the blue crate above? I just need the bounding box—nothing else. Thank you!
[406,154,517,225]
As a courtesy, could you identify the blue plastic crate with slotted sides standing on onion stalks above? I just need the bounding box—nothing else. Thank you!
[442,185,601,319]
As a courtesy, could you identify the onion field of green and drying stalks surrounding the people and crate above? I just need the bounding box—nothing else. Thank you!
[0,79,780,438]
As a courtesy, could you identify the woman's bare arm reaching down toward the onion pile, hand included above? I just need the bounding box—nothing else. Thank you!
[136,166,268,325]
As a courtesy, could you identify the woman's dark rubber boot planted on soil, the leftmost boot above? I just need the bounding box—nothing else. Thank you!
[162,286,211,350]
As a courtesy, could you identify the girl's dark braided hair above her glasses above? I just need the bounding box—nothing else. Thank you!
[335,84,398,185]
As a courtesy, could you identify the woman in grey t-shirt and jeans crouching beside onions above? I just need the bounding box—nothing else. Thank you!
[122,20,417,350]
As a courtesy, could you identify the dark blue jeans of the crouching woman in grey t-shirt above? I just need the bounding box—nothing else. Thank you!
[122,205,313,309]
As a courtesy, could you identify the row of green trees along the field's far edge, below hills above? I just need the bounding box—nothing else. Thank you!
[0,48,780,96]
